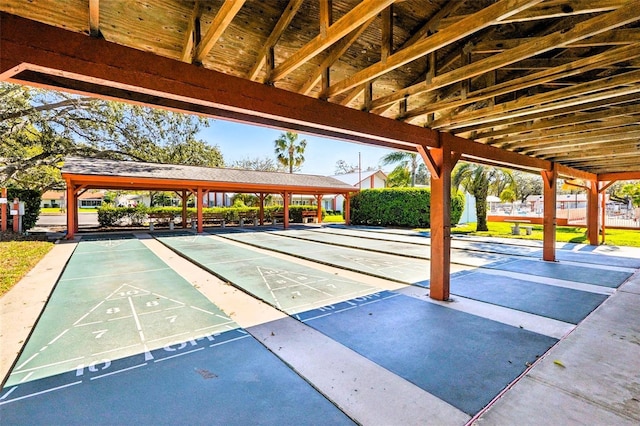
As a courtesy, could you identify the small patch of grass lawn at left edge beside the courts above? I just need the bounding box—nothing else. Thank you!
[0,241,53,296]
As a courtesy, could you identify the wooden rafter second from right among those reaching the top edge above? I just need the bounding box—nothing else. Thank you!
[267,0,395,82]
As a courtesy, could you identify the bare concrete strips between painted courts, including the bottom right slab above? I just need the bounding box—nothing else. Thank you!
[0,226,640,425]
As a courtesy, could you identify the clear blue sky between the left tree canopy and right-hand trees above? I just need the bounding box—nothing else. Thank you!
[198,120,393,176]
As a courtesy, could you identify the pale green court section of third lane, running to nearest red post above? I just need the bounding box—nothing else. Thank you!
[212,228,472,284]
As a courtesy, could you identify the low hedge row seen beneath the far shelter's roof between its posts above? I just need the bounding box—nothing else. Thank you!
[97,204,325,226]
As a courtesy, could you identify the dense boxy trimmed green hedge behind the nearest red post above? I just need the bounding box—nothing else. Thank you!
[351,188,464,228]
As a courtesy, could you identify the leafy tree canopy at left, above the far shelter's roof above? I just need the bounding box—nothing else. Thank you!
[0,83,223,191]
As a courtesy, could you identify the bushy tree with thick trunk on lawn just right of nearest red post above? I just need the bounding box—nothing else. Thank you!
[451,162,515,231]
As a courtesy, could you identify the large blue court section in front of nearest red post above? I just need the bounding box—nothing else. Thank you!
[299,292,557,415]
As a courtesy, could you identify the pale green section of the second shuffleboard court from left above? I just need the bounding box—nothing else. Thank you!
[154,234,377,314]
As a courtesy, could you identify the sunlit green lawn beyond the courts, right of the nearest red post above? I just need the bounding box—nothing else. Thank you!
[451,222,640,247]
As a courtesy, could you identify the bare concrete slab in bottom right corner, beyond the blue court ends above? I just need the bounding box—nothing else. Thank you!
[477,275,640,424]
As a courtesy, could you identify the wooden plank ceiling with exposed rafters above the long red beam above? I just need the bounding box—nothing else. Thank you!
[0,0,640,174]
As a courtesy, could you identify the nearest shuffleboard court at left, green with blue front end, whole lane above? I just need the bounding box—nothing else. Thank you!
[0,236,353,425]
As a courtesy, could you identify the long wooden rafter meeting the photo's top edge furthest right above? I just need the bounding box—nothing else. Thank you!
[324,0,542,99]
